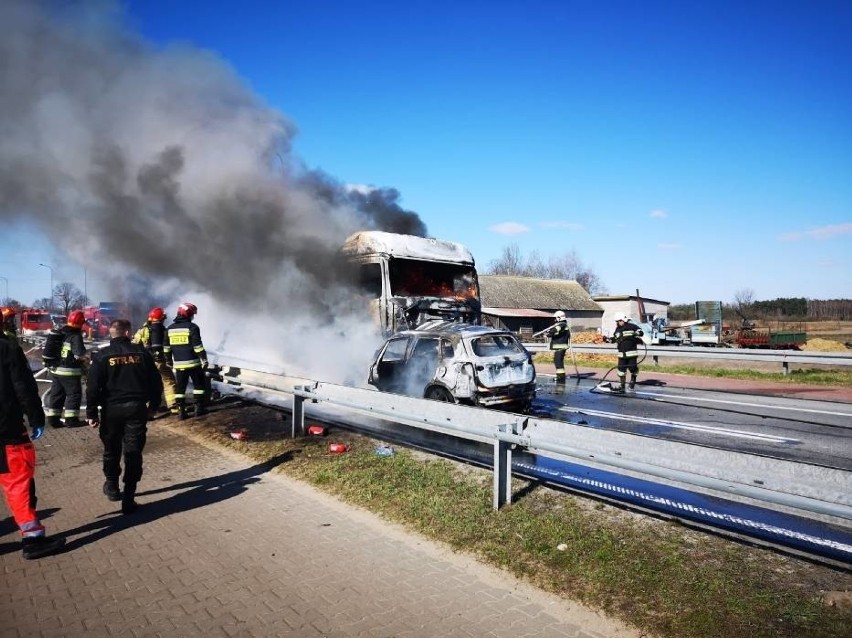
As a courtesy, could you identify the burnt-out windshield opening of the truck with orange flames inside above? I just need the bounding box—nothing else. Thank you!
[388,259,479,300]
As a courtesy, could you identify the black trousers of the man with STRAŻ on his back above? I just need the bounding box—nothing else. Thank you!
[100,403,148,485]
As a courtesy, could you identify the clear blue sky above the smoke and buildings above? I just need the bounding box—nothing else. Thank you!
[0,0,852,303]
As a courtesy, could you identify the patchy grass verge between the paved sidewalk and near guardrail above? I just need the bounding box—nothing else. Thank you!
[180,405,852,638]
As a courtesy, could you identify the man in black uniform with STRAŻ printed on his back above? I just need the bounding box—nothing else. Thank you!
[86,319,163,514]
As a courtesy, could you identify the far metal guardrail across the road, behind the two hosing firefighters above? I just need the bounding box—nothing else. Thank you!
[524,343,852,374]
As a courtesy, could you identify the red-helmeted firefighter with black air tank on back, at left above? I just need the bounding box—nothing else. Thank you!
[45,310,89,428]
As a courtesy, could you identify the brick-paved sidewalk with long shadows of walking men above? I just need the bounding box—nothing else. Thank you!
[0,421,638,638]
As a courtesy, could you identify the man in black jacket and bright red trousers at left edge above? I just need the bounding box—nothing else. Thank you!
[0,335,65,559]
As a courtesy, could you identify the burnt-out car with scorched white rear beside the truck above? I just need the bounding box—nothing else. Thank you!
[368,321,535,411]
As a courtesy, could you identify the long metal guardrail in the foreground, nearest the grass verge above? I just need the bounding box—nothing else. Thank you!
[208,357,852,529]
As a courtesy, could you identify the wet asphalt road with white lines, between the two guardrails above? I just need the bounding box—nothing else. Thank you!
[533,372,852,471]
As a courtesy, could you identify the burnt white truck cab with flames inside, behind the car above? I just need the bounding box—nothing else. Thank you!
[342,231,482,335]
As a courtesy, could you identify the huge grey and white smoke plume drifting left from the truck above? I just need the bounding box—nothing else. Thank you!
[0,0,426,381]
